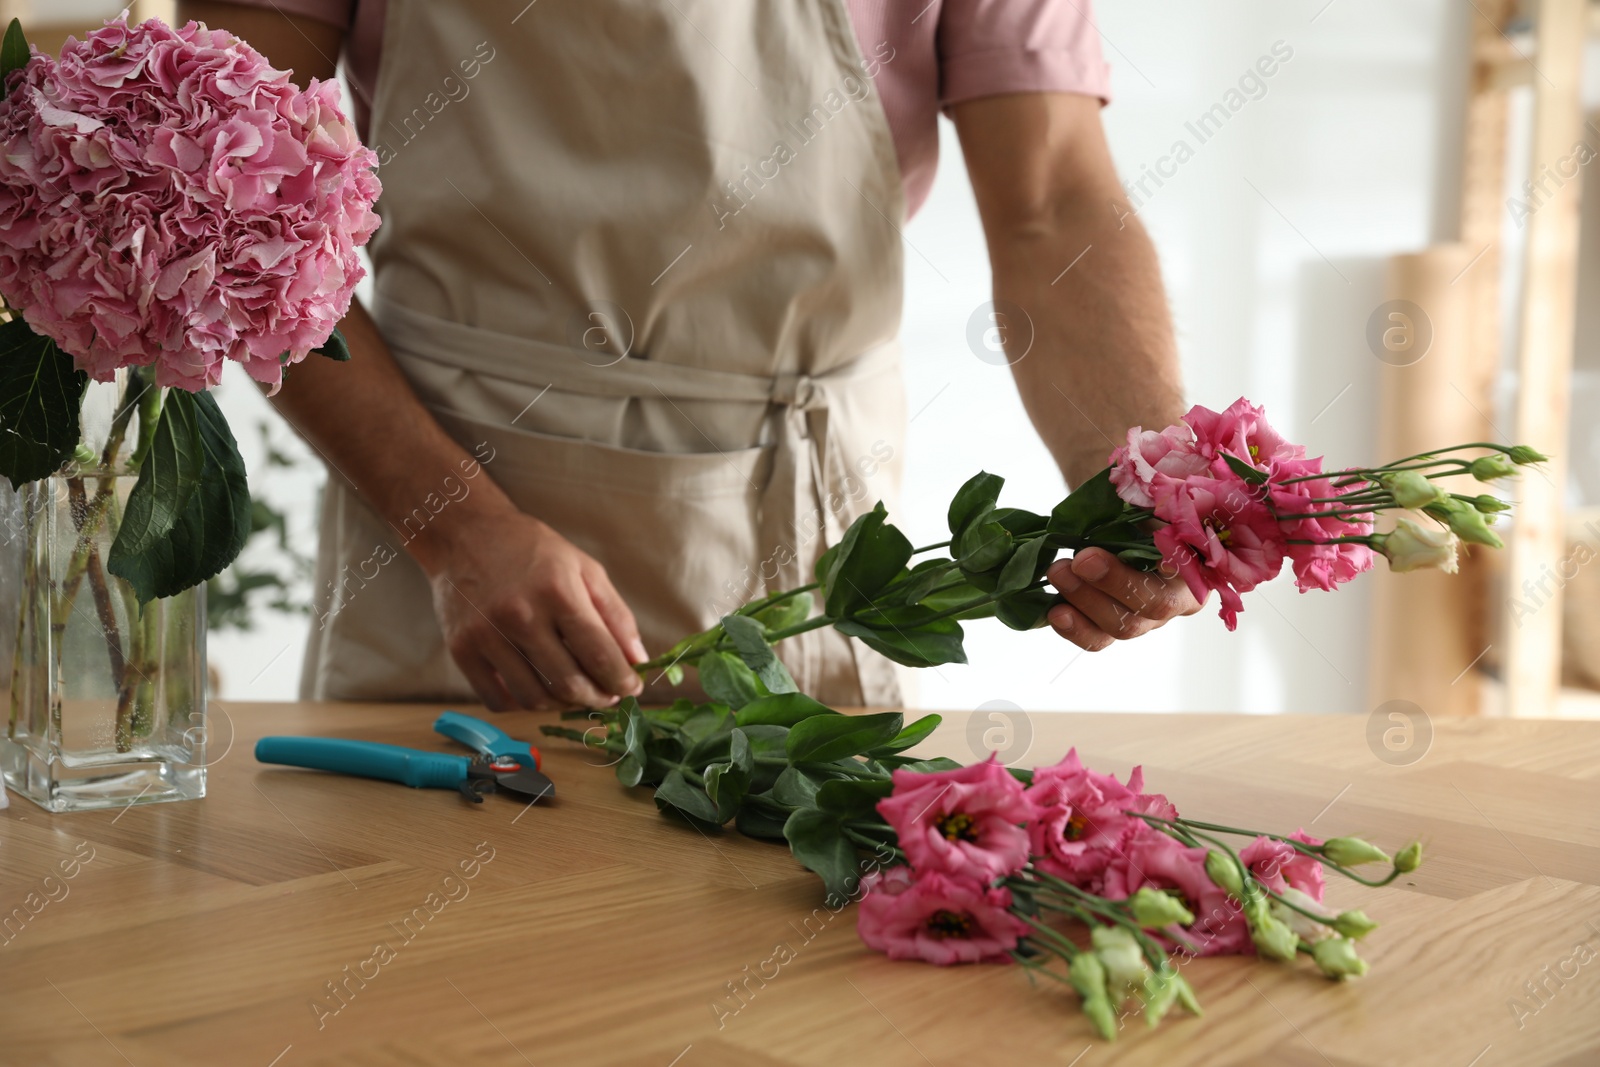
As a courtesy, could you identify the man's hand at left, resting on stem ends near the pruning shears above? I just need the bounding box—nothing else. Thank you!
[429,509,648,712]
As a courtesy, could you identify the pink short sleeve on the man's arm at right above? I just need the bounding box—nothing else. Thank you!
[938,0,1110,107]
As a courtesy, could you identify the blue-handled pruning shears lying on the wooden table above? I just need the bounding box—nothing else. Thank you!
[256,712,555,803]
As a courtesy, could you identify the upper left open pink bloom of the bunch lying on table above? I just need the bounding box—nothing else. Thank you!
[878,755,1034,883]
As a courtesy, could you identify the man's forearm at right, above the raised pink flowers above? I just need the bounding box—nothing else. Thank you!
[990,211,1184,485]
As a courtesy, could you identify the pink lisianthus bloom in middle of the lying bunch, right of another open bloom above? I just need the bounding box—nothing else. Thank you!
[1027,749,1178,893]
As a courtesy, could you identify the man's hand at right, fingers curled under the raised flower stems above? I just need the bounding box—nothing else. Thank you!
[1048,549,1202,653]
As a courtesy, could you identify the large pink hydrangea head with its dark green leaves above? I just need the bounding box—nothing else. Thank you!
[0,18,379,591]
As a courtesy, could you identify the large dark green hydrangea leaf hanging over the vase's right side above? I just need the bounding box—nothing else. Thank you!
[106,389,250,603]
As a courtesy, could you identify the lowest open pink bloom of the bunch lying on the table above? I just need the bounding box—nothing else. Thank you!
[856,867,1027,965]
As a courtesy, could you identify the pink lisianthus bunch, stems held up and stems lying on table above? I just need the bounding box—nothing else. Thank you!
[544,400,1544,1040]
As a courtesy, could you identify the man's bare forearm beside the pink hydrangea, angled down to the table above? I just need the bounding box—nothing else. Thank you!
[274,302,512,573]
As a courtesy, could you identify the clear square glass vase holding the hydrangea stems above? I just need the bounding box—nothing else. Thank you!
[0,469,206,811]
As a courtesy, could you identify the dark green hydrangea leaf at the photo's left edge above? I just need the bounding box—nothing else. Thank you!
[0,316,90,488]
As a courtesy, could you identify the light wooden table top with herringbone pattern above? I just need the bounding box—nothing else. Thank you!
[0,704,1600,1067]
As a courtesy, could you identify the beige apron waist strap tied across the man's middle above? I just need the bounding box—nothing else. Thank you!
[373,296,899,411]
